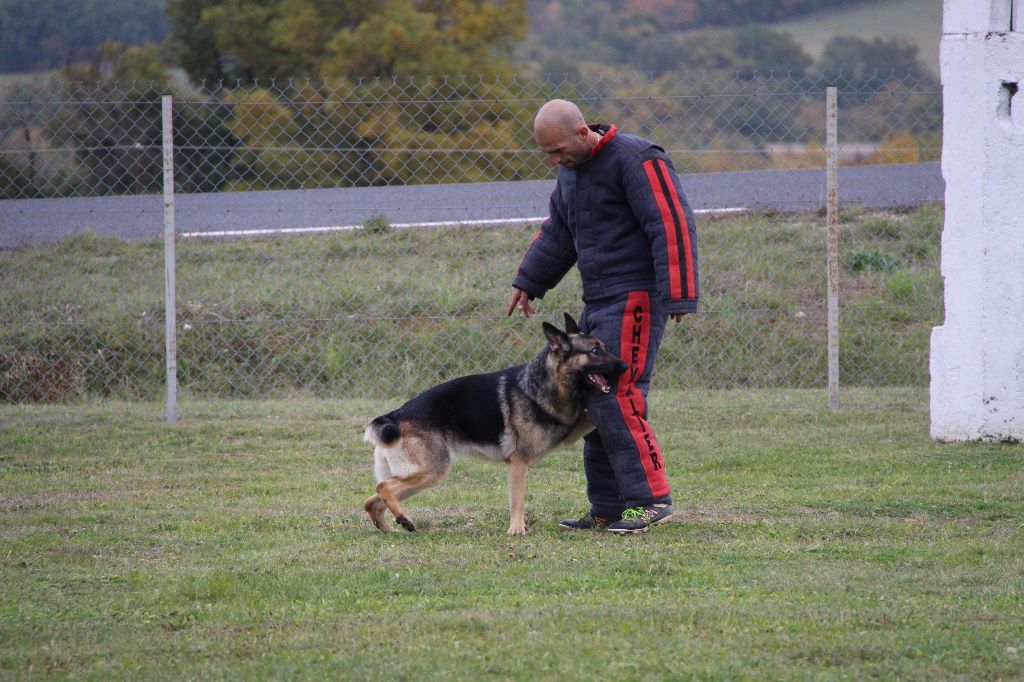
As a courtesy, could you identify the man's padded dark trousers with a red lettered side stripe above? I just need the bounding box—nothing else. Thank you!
[580,291,672,519]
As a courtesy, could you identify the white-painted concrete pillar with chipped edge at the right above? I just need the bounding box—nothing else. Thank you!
[931,0,1024,440]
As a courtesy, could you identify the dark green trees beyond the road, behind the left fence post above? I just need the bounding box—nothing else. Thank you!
[0,41,238,199]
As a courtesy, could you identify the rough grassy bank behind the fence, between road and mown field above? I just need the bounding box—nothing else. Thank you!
[0,206,943,402]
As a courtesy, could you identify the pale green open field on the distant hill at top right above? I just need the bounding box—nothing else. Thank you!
[771,0,942,76]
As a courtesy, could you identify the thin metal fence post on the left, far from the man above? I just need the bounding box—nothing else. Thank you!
[161,95,178,424]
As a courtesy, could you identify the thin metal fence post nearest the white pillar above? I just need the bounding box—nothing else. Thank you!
[825,87,839,410]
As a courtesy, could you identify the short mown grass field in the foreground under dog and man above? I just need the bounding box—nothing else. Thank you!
[0,385,1024,680]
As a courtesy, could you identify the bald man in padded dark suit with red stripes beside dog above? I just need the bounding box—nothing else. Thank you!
[507,99,697,532]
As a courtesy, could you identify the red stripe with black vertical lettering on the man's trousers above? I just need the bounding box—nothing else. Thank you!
[615,291,672,498]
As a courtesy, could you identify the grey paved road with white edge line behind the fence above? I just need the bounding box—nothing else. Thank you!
[0,163,945,249]
